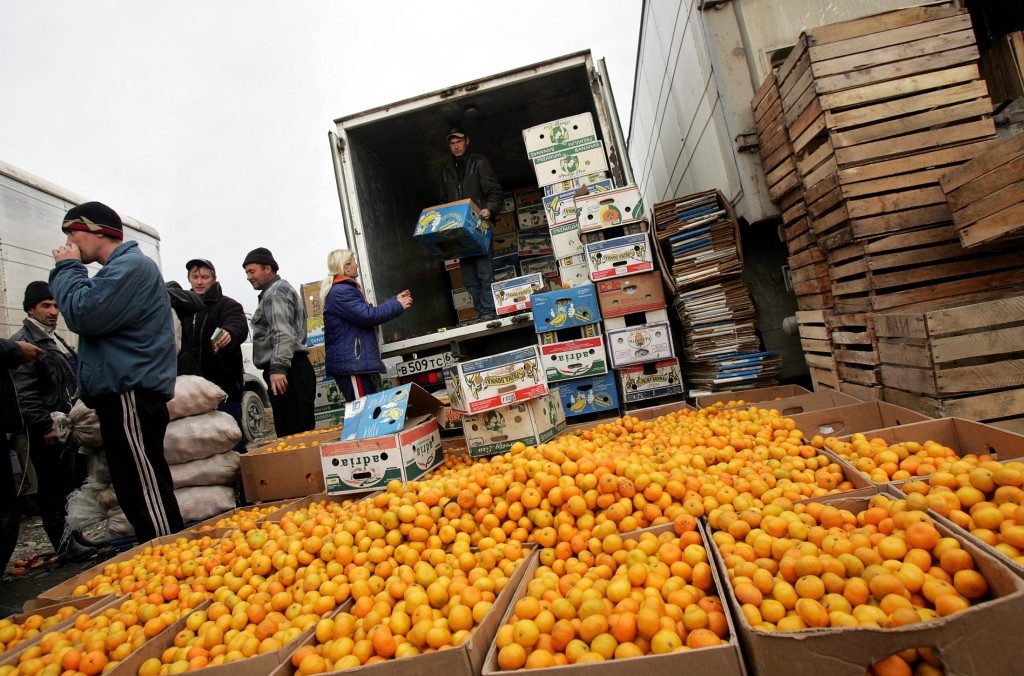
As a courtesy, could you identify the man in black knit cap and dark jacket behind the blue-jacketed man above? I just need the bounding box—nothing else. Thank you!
[11,282,96,561]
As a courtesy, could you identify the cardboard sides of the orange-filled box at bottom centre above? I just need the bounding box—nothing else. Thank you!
[477,523,746,676]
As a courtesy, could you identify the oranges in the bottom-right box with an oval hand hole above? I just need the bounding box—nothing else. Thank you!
[708,495,988,631]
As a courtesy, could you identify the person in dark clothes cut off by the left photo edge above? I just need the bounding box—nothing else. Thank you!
[0,338,43,571]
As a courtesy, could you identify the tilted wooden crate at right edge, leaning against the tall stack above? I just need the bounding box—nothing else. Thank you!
[940,127,1024,247]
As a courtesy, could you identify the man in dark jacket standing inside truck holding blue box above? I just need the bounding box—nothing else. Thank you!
[440,127,503,322]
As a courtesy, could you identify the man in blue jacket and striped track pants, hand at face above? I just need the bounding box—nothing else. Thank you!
[49,202,183,542]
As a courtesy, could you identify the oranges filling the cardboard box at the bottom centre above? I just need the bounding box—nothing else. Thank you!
[496,521,728,671]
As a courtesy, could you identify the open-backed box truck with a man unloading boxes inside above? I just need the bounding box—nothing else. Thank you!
[328,50,632,376]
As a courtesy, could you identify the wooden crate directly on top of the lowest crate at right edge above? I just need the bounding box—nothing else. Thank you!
[828,224,1024,313]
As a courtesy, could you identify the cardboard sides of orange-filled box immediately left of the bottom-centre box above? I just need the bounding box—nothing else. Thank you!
[266,545,540,676]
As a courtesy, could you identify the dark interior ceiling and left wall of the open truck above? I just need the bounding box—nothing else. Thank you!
[338,59,601,342]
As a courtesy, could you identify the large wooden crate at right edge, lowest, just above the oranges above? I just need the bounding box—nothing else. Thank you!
[874,293,1024,425]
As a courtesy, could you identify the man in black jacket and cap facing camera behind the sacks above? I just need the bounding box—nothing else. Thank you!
[171,258,249,453]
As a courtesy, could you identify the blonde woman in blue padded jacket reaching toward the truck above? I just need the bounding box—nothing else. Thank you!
[321,249,413,402]
